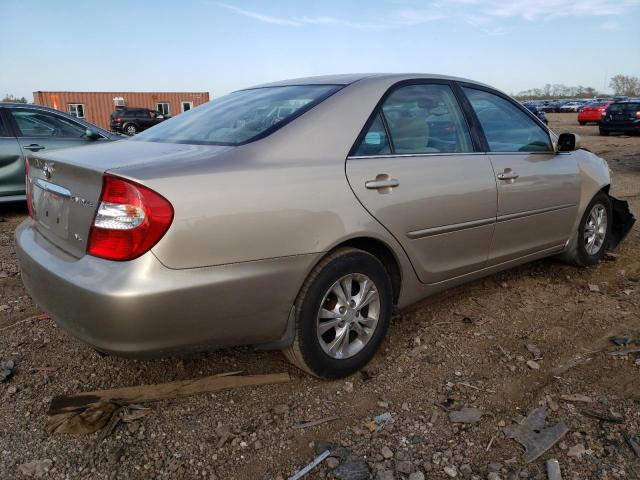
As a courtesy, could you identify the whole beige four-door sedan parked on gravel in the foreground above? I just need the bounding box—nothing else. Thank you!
[16,74,634,378]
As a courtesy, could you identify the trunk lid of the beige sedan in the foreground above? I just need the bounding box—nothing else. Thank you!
[26,141,233,258]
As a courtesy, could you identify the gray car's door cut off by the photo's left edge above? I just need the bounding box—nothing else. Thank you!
[0,108,25,201]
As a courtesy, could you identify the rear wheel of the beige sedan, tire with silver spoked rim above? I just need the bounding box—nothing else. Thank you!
[283,248,393,379]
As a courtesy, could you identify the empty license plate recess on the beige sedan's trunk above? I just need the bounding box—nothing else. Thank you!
[31,178,71,239]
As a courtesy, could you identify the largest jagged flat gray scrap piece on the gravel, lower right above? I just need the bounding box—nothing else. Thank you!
[504,407,569,463]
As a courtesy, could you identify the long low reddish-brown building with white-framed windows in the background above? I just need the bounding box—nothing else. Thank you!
[33,91,209,130]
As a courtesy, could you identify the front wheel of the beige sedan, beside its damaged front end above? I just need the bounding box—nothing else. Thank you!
[560,192,613,267]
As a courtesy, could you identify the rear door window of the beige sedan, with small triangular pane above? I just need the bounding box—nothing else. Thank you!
[355,84,473,155]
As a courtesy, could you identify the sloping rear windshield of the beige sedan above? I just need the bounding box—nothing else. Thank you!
[133,85,341,145]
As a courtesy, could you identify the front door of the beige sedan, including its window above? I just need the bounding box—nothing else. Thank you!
[463,86,580,265]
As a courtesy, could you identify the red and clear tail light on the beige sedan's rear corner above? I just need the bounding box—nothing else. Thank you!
[87,176,173,260]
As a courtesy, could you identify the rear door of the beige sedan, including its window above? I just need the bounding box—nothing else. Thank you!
[346,81,496,283]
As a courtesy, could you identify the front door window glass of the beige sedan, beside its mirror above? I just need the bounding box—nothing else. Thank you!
[463,87,553,152]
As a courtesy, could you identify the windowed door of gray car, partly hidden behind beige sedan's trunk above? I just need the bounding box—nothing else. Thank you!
[8,107,93,154]
